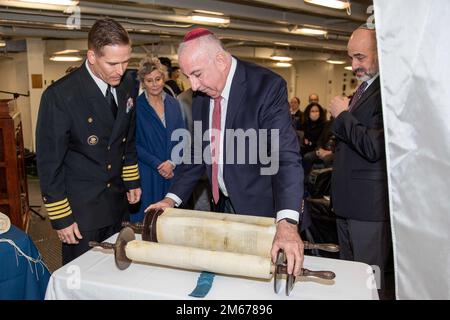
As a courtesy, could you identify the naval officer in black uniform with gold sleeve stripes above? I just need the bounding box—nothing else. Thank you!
[36,19,141,264]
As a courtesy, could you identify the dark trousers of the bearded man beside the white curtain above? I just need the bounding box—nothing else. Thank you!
[336,217,392,299]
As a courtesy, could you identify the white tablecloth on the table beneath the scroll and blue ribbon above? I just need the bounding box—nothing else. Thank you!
[45,234,378,300]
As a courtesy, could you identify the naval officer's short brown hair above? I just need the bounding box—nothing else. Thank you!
[88,18,131,55]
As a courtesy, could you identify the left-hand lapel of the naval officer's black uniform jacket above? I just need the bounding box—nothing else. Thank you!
[79,63,114,133]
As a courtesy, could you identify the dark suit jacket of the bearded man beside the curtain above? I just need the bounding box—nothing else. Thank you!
[332,78,389,221]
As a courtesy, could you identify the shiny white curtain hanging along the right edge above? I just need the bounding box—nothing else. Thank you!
[374,0,450,299]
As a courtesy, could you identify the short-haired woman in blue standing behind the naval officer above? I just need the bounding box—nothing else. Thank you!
[130,58,185,222]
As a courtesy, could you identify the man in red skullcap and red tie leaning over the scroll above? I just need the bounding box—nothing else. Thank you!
[149,29,303,275]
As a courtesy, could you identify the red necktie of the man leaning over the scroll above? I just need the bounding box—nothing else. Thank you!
[211,97,222,203]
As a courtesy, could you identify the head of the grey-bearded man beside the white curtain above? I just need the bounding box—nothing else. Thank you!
[347,27,378,81]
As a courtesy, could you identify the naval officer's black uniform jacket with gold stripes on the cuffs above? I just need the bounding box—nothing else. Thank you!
[36,64,139,230]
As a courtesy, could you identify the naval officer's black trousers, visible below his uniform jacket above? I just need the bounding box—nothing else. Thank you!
[62,221,122,265]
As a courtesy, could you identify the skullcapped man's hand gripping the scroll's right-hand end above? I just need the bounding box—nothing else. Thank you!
[271,220,304,276]
